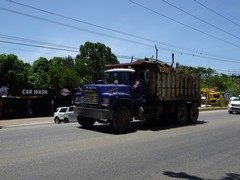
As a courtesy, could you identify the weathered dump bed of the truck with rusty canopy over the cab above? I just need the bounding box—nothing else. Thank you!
[107,60,201,102]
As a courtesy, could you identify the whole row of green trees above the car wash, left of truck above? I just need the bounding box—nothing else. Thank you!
[0,42,119,88]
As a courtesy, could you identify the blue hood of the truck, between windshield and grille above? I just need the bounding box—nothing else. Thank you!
[83,84,131,94]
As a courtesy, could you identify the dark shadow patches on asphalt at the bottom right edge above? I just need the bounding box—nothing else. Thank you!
[163,171,240,180]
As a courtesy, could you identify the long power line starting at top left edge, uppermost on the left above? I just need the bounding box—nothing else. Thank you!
[7,0,240,63]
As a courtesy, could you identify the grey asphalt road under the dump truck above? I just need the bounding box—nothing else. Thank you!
[0,110,240,180]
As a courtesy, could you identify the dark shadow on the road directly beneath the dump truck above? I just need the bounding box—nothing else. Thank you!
[78,121,207,134]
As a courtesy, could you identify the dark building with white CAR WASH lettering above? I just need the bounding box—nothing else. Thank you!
[0,86,78,119]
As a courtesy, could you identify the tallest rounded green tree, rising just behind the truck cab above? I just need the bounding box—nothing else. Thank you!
[76,42,119,82]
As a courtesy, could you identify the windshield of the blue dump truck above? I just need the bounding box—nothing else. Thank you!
[105,72,132,85]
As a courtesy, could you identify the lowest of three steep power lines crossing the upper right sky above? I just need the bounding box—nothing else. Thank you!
[129,0,240,49]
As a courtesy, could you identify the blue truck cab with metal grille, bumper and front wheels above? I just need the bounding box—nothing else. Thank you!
[75,65,148,132]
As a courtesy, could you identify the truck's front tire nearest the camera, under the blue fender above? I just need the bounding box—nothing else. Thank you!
[111,106,131,133]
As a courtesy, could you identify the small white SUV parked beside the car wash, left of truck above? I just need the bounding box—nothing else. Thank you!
[54,106,77,124]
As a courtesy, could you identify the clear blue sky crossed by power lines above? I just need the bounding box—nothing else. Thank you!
[0,0,240,74]
